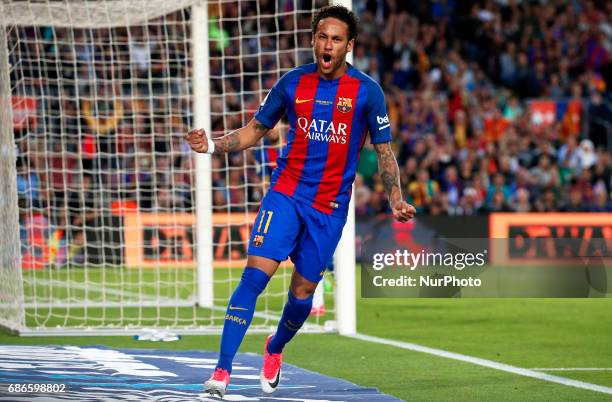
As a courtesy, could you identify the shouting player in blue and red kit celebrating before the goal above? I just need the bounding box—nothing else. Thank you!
[186,6,415,396]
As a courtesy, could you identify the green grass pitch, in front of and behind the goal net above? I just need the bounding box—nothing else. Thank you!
[0,269,612,401]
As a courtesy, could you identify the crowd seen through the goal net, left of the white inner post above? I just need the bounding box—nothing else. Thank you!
[13,11,193,220]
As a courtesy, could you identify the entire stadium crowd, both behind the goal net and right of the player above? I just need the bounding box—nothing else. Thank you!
[9,0,612,232]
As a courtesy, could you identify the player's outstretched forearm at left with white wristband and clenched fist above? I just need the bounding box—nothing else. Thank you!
[185,119,269,155]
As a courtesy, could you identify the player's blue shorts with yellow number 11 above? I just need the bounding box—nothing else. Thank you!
[248,190,346,283]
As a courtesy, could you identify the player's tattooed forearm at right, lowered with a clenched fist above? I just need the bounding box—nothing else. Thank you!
[374,142,416,222]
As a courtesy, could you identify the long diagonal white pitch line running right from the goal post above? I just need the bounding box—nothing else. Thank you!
[347,334,612,395]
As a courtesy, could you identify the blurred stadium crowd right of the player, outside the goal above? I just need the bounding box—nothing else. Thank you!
[354,0,612,216]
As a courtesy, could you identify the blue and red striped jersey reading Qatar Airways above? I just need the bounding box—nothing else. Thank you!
[255,63,391,216]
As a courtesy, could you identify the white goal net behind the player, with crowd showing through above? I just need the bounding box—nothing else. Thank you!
[0,0,346,335]
